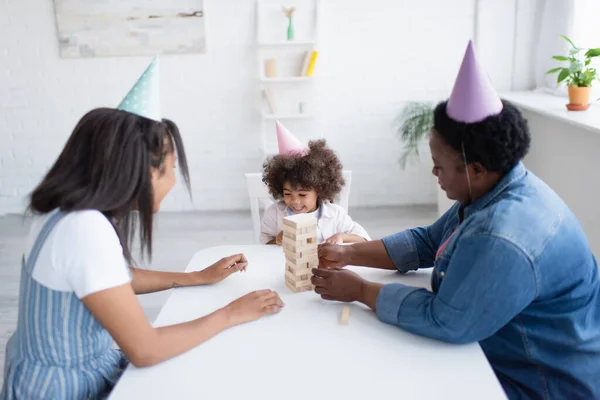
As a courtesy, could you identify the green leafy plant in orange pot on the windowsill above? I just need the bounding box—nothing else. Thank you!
[546,35,600,111]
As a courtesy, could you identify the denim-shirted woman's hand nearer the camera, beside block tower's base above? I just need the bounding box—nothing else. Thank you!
[311,268,365,302]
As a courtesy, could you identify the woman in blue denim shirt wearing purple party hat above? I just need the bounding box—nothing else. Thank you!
[312,41,600,400]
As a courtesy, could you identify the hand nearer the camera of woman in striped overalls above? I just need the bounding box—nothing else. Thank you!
[223,289,284,326]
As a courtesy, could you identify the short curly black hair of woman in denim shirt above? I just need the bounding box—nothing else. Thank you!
[433,100,531,174]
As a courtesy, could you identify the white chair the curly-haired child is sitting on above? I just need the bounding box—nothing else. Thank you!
[245,171,352,243]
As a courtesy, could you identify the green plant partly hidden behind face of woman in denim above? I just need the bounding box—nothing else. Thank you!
[395,101,454,215]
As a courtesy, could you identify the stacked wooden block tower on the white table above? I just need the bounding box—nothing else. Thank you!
[282,214,319,292]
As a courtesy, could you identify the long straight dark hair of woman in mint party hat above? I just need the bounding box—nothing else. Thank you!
[29,108,190,263]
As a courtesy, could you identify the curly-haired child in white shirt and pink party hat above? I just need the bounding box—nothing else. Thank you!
[260,122,371,245]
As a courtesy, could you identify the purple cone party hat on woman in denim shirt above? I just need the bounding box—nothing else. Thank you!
[446,40,503,123]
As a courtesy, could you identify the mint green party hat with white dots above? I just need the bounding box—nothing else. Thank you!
[117,57,162,122]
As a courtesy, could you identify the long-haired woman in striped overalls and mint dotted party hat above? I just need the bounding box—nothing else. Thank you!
[0,60,283,399]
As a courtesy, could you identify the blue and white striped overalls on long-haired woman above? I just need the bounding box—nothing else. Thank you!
[0,211,127,400]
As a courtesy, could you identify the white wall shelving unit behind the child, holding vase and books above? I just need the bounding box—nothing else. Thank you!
[256,0,319,155]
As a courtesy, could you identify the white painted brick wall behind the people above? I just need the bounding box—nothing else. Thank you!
[0,0,516,214]
